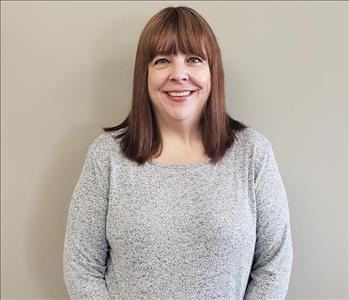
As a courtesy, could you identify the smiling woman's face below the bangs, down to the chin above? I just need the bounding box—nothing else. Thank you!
[148,52,211,124]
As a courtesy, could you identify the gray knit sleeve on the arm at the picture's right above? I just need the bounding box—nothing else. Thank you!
[244,136,293,300]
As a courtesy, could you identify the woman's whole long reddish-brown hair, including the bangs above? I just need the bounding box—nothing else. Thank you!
[103,6,247,165]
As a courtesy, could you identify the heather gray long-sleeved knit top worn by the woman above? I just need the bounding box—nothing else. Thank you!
[63,128,293,300]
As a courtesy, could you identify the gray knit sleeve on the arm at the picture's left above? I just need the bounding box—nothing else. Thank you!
[63,138,111,300]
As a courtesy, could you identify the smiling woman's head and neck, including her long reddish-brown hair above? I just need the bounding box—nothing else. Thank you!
[100,7,247,165]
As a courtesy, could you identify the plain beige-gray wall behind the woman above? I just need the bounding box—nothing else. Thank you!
[1,1,349,299]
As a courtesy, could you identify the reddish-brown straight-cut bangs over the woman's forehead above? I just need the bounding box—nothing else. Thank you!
[145,10,207,62]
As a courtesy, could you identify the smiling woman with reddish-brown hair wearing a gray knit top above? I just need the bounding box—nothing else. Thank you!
[64,7,293,300]
